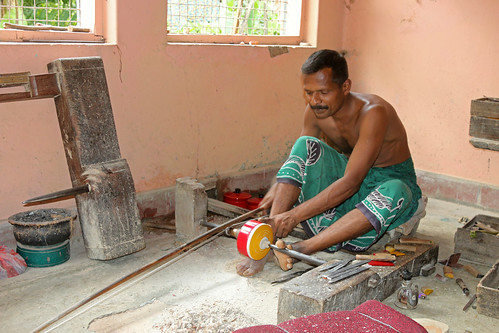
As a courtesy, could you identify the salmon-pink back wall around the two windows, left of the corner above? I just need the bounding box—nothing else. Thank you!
[0,0,343,219]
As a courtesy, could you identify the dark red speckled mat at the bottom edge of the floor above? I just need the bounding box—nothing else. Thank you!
[234,300,427,333]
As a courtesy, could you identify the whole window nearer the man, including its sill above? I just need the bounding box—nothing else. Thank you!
[167,0,302,43]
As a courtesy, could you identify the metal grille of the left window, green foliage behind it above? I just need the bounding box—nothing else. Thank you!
[0,0,80,28]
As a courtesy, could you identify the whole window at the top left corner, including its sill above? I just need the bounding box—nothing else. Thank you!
[0,0,103,42]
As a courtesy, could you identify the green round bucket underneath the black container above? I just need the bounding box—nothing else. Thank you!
[16,239,69,267]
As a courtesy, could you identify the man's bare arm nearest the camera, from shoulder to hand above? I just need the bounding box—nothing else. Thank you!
[275,106,388,237]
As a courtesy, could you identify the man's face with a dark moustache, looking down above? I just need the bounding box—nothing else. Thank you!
[301,68,349,119]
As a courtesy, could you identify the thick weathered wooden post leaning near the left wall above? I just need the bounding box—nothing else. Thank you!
[48,57,145,260]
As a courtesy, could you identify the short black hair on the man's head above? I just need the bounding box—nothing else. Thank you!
[301,49,348,86]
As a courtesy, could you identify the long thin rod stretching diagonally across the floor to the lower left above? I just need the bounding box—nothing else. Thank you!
[32,207,263,332]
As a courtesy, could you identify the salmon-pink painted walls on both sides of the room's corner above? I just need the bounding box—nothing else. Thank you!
[0,0,499,219]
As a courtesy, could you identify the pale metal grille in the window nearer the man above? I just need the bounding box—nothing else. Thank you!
[167,0,296,36]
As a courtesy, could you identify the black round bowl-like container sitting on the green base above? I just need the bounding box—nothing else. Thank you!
[8,208,76,246]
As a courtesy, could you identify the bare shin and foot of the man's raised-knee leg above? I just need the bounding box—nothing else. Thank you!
[236,183,301,276]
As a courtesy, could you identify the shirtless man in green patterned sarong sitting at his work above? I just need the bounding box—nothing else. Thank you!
[237,50,421,276]
